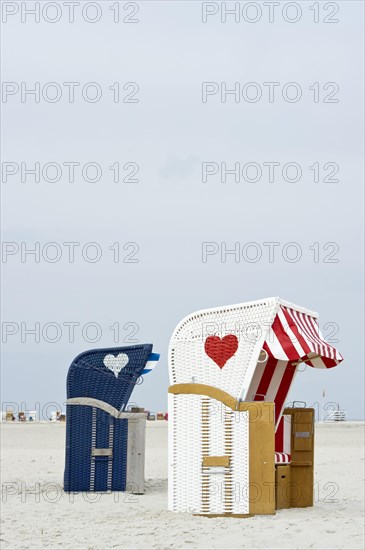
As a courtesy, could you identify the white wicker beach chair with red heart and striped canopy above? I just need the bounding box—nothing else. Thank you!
[168,298,342,517]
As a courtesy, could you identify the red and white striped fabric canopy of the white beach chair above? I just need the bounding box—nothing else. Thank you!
[247,305,343,425]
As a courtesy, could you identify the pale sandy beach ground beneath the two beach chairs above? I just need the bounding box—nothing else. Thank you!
[1,421,364,550]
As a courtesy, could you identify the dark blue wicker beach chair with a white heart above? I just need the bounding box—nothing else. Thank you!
[64,344,160,492]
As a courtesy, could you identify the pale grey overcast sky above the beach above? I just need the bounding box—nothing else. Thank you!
[2,1,364,419]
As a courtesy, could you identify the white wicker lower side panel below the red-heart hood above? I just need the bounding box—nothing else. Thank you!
[169,394,249,514]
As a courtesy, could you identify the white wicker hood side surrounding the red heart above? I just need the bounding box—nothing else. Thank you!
[169,298,280,400]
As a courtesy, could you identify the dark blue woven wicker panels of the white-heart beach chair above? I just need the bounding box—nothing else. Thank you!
[64,344,152,492]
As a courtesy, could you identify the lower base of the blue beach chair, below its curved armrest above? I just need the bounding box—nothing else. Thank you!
[64,410,146,494]
